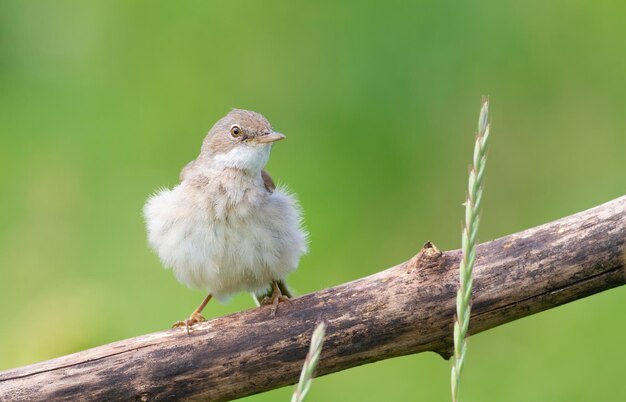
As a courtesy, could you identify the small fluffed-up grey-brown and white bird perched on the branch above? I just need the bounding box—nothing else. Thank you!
[143,109,308,332]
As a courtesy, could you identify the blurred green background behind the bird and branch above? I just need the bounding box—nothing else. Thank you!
[0,0,626,401]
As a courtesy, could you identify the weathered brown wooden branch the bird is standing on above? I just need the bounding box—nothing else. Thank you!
[0,196,626,401]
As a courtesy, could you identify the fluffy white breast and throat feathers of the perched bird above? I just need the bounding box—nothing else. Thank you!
[144,167,307,299]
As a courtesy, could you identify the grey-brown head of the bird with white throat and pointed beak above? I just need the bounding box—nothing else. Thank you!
[201,109,285,174]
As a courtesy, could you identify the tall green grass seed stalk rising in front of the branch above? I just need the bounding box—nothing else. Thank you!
[450,98,489,402]
